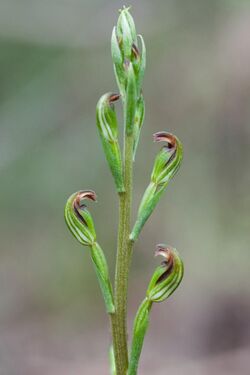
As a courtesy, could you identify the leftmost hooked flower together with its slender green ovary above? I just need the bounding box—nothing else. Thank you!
[64,190,115,314]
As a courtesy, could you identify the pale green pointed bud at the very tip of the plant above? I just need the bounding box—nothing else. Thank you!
[117,7,137,60]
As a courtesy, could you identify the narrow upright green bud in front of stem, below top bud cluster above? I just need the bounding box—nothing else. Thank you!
[125,63,137,135]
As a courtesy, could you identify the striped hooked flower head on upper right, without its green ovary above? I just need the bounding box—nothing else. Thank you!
[151,132,182,185]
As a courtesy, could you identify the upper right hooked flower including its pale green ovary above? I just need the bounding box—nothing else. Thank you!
[130,132,183,241]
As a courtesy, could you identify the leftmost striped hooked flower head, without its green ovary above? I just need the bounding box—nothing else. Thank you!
[64,190,96,246]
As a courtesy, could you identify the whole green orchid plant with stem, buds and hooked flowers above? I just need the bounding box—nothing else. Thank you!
[65,7,183,375]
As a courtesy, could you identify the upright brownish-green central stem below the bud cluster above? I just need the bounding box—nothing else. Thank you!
[111,134,134,375]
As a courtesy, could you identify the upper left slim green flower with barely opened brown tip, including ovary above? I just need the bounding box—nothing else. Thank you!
[96,93,124,192]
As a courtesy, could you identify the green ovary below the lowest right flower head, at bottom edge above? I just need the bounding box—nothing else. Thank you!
[128,298,152,375]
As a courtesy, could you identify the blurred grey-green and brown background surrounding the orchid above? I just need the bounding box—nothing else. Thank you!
[0,0,250,375]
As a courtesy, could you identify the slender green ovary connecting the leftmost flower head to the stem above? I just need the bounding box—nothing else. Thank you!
[91,242,115,314]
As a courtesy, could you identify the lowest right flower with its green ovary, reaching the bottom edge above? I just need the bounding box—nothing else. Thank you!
[128,244,183,375]
